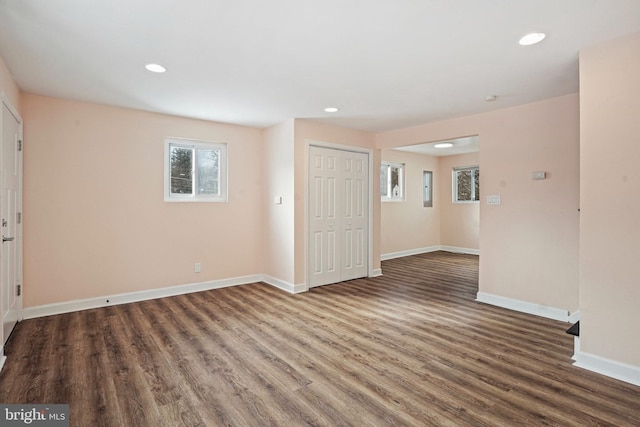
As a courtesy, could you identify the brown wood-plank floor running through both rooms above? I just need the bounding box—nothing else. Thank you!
[0,252,640,426]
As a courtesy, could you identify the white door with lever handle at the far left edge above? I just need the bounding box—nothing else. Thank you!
[0,98,22,344]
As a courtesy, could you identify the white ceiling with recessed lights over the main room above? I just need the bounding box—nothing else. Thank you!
[0,0,640,131]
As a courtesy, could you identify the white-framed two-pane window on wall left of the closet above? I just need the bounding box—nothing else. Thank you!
[164,138,227,202]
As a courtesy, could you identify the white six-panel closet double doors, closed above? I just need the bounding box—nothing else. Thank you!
[308,146,369,287]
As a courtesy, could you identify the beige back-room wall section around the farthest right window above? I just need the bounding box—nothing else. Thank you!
[438,153,483,250]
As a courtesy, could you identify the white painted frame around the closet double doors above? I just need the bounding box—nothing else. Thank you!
[304,140,377,290]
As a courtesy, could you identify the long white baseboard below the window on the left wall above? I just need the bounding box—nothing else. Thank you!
[22,274,263,319]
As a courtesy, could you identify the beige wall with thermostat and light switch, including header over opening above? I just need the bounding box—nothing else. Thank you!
[376,94,579,312]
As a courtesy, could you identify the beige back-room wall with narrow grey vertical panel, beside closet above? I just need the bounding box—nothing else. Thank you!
[377,150,441,255]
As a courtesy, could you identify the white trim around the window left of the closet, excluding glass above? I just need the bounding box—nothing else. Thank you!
[164,138,228,202]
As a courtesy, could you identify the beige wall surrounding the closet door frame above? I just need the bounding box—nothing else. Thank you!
[295,119,380,284]
